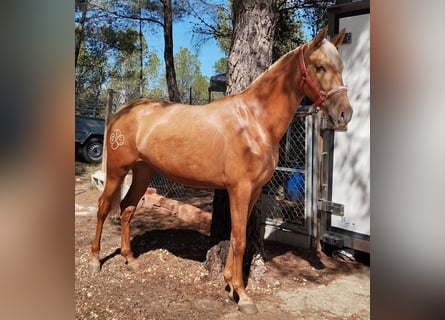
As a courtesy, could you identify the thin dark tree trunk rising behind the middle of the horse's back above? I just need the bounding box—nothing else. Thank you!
[163,0,181,102]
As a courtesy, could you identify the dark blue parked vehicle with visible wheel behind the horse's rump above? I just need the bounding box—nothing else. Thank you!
[76,116,105,163]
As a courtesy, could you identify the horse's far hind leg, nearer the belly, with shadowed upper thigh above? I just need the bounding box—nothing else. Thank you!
[121,162,154,271]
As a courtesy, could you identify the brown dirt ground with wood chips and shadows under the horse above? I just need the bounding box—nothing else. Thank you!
[75,162,370,320]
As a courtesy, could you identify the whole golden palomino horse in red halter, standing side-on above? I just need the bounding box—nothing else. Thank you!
[90,29,352,313]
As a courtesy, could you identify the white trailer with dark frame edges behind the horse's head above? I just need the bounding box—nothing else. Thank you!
[320,1,371,253]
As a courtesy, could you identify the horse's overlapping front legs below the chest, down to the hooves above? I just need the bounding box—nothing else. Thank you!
[224,183,258,314]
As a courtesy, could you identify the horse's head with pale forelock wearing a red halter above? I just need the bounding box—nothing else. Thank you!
[299,28,353,128]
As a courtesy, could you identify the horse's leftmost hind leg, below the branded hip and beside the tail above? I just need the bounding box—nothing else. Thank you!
[89,172,126,274]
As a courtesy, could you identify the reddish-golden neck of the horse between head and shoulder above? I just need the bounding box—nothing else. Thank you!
[242,48,304,144]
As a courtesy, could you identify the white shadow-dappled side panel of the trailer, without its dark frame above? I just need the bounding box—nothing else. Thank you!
[331,14,370,235]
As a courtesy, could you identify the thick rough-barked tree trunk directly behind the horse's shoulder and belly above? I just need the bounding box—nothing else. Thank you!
[206,0,278,278]
